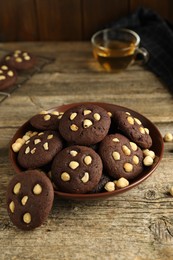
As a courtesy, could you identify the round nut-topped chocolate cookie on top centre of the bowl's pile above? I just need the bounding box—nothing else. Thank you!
[59,104,111,146]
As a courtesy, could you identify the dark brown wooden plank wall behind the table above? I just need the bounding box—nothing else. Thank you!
[0,0,173,42]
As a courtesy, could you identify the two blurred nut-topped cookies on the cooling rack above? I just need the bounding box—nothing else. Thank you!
[0,50,36,90]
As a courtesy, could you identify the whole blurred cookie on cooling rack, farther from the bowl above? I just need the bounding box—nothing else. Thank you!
[3,50,36,70]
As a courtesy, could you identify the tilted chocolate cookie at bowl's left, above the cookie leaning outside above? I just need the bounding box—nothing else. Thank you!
[17,131,63,169]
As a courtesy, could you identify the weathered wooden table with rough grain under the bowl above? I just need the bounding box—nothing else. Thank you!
[0,42,173,260]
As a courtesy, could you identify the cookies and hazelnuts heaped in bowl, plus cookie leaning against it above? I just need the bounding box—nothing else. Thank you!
[7,103,155,230]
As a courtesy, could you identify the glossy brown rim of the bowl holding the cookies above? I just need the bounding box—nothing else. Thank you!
[9,102,164,200]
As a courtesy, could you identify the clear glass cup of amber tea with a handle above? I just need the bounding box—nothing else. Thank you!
[91,28,149,71]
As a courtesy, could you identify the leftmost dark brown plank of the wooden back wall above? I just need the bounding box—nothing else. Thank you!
[0,0,38,42]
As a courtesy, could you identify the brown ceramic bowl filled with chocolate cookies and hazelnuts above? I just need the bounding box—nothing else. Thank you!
[10,102,164,200]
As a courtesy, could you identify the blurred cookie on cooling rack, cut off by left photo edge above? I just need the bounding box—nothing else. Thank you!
[0,64,17,90]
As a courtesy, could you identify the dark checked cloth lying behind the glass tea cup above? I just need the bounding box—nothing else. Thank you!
[106,7,173,92]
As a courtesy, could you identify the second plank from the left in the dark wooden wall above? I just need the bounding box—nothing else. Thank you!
[36,0,82,41]
